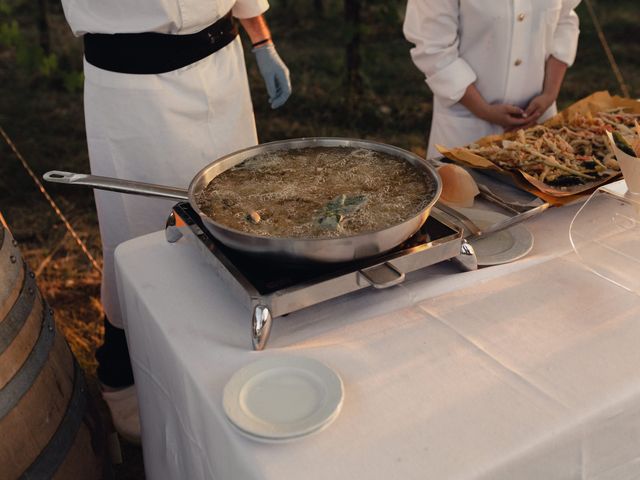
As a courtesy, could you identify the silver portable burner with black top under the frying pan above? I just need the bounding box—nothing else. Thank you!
[165,202,477,350]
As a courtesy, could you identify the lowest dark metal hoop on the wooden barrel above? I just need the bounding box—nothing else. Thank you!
[19,358,87,480]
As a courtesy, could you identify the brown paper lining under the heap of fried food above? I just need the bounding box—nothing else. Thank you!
[436,92,640,205]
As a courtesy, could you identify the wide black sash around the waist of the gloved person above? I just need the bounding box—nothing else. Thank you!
[84,11,238,74]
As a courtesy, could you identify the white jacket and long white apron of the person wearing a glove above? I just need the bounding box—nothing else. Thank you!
[62,0,269,327]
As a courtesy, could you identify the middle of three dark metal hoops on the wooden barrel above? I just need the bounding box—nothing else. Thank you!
[0,300,56,420]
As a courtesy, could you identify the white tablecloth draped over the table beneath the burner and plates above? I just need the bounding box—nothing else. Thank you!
[116,206,640,480]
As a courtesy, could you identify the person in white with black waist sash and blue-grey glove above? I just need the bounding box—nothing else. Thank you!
[62,0,291,441]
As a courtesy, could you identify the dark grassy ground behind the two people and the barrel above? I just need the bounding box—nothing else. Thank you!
[0,0,640,479]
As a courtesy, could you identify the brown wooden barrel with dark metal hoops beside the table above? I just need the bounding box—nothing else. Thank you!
[0,225,110,479]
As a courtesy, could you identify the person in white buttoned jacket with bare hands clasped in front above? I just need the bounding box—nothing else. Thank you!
[404,0,580,158]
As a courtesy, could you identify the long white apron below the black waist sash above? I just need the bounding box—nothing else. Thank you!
[84,37,257,328]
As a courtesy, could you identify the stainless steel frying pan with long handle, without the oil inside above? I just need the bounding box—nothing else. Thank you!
[44,137,442,263]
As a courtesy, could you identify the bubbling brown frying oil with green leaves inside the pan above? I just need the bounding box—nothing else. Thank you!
[196,147,436,238]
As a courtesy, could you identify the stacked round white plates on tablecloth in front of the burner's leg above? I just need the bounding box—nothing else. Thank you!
[222,355,344,441]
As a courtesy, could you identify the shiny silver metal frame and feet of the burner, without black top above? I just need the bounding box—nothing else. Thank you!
[165,202,478,350]
